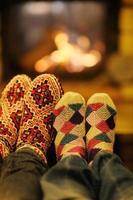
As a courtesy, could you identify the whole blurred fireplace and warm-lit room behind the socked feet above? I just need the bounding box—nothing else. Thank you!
[0,0,133,171]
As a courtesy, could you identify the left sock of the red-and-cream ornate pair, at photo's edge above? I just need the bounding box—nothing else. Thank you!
[0,75,31,158]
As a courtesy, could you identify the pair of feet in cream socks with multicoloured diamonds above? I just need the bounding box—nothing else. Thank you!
[53,92,116,163]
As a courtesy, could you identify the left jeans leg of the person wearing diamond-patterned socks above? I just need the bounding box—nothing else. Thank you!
[41,156,95,200]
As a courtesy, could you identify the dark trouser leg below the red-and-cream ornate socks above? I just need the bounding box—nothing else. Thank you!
[0,150,46,200]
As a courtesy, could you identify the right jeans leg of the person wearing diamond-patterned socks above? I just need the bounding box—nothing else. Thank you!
[92,152,133,200]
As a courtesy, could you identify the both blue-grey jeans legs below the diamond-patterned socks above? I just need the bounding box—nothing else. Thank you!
[41,151,133,200]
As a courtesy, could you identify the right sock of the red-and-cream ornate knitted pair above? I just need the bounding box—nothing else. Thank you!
[16,74,63,162]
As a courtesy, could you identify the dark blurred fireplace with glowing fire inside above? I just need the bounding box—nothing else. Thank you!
[2,1,120,79]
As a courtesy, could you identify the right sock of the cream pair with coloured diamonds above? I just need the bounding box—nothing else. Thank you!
[86,93,116,161]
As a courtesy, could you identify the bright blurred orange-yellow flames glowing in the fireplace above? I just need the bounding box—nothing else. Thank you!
[35,32,102,72]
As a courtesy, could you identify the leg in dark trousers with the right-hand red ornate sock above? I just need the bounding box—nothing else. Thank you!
[0,74,62,200]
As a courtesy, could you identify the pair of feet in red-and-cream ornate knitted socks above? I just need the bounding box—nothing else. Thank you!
[0,74,63,160]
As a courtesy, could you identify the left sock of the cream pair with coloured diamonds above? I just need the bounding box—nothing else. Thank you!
[53,92,85,160]
